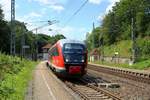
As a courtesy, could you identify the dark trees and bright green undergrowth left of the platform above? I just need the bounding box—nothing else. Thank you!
[0,4,65,100]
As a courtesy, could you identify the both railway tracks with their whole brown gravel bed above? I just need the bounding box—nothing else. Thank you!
[46,62,150,100]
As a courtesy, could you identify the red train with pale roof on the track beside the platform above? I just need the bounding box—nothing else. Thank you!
[47,39,87,78]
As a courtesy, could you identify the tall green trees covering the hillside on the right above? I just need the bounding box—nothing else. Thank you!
[86,0,150,59]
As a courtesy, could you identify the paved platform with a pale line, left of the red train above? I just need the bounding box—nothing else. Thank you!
[25,62,79,100]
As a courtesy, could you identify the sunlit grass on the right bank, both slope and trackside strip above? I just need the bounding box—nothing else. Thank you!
[93,39,150,70]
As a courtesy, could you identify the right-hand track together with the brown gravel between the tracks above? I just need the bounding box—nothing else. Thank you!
[88,65,150,100]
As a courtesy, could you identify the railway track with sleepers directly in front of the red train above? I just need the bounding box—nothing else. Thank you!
[64,76,121,100]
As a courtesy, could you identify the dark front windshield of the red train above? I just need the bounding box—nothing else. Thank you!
[63,43,85,63]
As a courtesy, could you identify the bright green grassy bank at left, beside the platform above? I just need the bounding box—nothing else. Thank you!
[0,54,37,100]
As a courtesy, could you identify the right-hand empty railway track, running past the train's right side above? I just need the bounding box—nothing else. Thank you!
[88,64,150,84]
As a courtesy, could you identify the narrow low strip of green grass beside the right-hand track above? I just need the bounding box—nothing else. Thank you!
[92,59,150,70]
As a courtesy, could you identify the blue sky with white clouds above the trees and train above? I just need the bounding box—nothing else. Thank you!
[0,0,119,40]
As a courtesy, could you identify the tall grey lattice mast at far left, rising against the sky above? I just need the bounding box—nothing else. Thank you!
[10,0,16,56]
